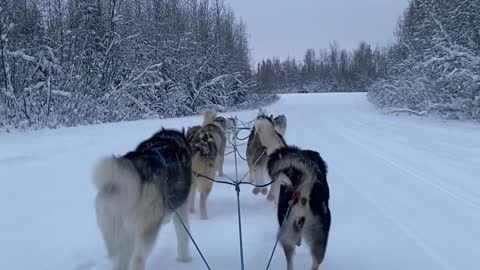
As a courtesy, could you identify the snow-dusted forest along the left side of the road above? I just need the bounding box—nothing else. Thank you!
[0,0,261,129]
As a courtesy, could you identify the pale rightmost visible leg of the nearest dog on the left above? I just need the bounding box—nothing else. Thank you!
[173,203,192,262]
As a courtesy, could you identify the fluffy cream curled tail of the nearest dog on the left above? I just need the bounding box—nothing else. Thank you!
[93,156,141,211]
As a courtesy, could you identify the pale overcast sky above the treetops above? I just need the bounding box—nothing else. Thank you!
[225,0,408,61]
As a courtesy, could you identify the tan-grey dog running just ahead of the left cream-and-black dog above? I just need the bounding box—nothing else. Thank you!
[187,111,225,219]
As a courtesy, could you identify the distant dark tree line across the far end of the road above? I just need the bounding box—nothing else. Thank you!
[256,42,386,92]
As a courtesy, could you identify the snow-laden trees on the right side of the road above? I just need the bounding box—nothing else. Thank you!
[368,0,480,120]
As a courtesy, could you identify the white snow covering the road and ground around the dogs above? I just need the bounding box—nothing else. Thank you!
[0,93,480,270]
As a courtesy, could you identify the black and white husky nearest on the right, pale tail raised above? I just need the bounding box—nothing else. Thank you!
[255,117,331,270]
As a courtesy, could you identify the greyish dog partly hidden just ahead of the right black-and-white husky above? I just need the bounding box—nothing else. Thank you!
[247,111,286,196]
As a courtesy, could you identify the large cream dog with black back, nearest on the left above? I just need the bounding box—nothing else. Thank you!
[93,129,192,270]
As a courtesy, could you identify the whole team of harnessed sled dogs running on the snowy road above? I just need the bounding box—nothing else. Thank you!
[93,110,331,270]
